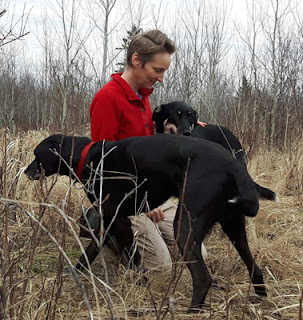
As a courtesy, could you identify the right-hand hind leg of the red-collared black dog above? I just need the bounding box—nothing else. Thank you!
[220,213,267,296]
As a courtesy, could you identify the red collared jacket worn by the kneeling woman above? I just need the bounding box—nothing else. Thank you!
[90,73,154,141]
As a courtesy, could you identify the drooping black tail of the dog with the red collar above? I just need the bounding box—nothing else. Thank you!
[228,165,259,217]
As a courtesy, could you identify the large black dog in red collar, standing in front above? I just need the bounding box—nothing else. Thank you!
[25,134,266,311]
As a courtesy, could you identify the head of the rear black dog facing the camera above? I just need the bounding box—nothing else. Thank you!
[153,101,198,136]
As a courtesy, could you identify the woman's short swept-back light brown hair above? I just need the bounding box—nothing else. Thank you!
[127,30,176,67]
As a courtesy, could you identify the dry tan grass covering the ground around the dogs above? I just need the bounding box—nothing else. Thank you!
[0,131,303,320]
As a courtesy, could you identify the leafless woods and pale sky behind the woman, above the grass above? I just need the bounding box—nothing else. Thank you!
[0,0,303,148]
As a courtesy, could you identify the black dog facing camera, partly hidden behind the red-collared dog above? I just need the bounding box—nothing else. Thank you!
[153,101,277,200]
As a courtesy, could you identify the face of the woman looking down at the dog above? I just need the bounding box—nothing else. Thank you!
[134,52,171,89]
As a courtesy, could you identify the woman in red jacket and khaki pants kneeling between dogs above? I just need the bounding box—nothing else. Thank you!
[90,30,205,267]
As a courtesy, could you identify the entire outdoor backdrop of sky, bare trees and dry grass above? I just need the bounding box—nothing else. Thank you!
[0,0,303,320]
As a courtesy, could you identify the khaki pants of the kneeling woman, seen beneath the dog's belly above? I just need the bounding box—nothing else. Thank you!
[129,200,207,268]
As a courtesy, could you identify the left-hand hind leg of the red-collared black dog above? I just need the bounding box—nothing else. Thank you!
[174,214,212,312]
